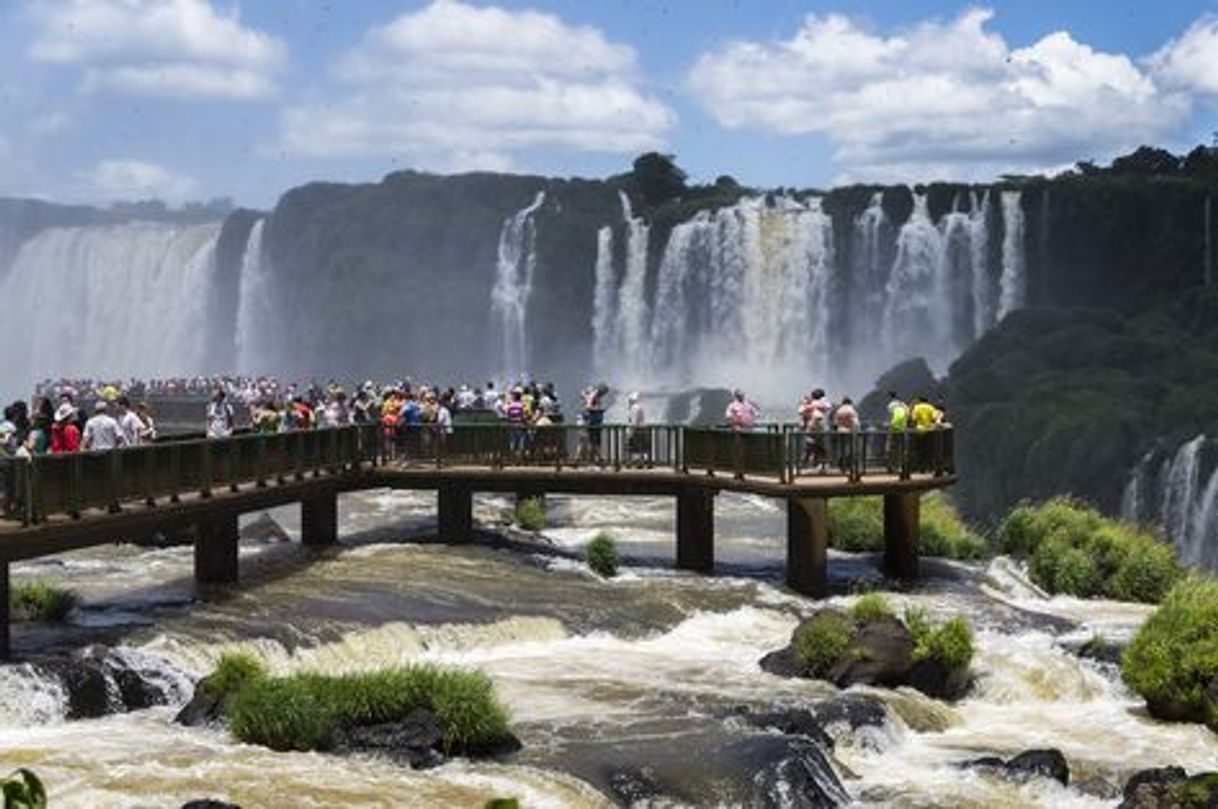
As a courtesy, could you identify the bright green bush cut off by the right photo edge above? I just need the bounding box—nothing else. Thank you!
[1121,576,1218,732]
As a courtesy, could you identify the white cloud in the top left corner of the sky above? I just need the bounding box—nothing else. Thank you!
[29,0,286,100]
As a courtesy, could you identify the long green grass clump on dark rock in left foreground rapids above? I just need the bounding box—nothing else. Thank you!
[229,665,508,752]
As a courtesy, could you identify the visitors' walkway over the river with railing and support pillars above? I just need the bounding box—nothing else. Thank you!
[0,424,956,657]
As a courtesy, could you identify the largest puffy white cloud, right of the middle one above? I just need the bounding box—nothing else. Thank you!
[688,9,1190,179]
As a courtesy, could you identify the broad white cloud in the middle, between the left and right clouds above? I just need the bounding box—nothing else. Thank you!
[279,0,675,168]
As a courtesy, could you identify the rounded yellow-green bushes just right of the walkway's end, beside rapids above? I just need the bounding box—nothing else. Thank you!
[999,497,1184,603]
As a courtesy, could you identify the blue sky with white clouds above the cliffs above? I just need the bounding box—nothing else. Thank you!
[0,0,1218,207]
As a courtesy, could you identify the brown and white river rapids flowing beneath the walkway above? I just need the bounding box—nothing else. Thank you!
[0,492,1218,807]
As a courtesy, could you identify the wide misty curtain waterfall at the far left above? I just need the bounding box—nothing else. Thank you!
[0,223,219,390]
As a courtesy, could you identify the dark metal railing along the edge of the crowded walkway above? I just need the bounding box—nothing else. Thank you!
[0,423,954,524]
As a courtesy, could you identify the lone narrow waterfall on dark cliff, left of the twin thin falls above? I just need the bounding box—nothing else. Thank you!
[491,191,546,376]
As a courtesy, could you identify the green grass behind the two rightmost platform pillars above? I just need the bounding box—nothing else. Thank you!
[828,493,989,559]
